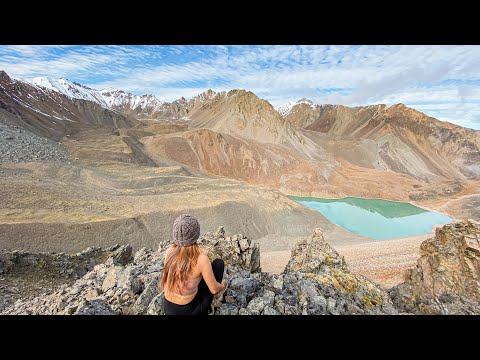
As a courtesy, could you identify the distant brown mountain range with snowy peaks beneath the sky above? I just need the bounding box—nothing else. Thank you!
[0,68,480,208]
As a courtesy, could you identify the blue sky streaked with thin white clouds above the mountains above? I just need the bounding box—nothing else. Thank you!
[0,45,480,129]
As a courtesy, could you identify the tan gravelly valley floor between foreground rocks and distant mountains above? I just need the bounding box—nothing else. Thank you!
[0,125,480,297]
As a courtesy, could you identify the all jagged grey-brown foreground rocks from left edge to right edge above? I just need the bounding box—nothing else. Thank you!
[0,221,480,315]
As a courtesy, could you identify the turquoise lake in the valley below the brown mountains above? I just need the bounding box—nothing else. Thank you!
[290,196,452,240]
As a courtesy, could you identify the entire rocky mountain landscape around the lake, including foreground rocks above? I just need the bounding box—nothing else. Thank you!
[0,71,480,314]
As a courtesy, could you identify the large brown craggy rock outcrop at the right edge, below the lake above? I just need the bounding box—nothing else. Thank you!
[390,220,480,314]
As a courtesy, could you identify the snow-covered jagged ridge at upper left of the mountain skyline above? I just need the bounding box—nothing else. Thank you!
[31,77,164,113]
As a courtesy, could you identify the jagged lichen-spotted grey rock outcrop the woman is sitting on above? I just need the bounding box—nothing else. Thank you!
[3,228,396,315]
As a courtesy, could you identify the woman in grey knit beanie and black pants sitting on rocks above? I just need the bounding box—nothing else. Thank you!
[160,214,226,315]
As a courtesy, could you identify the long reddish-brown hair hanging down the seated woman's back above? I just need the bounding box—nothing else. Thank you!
[159,244,200,294]
